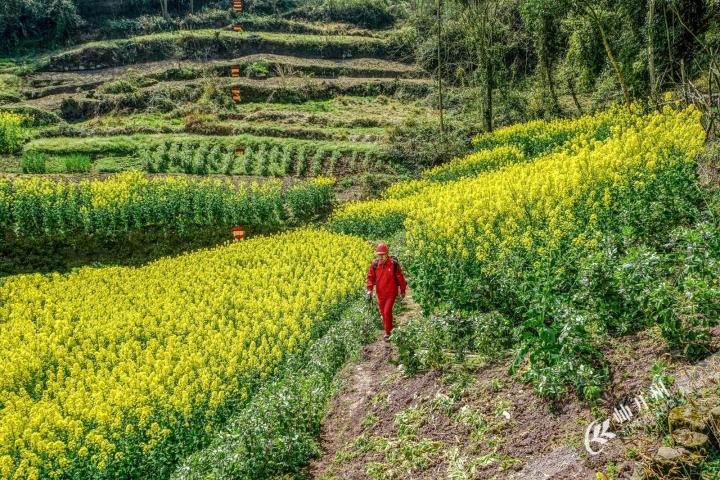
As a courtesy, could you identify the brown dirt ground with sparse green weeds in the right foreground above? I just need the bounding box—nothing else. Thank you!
[306,293,700,480]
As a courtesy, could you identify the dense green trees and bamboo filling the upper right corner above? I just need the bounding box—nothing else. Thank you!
[404,0,720,131]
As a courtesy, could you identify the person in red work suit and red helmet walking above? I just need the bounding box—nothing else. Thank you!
[367,243,407,340]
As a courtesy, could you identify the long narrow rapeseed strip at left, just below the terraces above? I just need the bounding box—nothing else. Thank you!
[0,171,334,239]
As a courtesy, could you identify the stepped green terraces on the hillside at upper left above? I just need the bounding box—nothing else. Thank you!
[0,17,434,197]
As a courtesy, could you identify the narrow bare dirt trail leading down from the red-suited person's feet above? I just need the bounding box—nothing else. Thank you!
[308,289,420,478]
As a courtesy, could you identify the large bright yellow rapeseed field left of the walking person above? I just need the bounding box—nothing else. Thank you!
[0,230,371,479]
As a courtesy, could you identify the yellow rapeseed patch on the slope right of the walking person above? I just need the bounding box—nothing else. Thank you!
[404,108,705,304]
